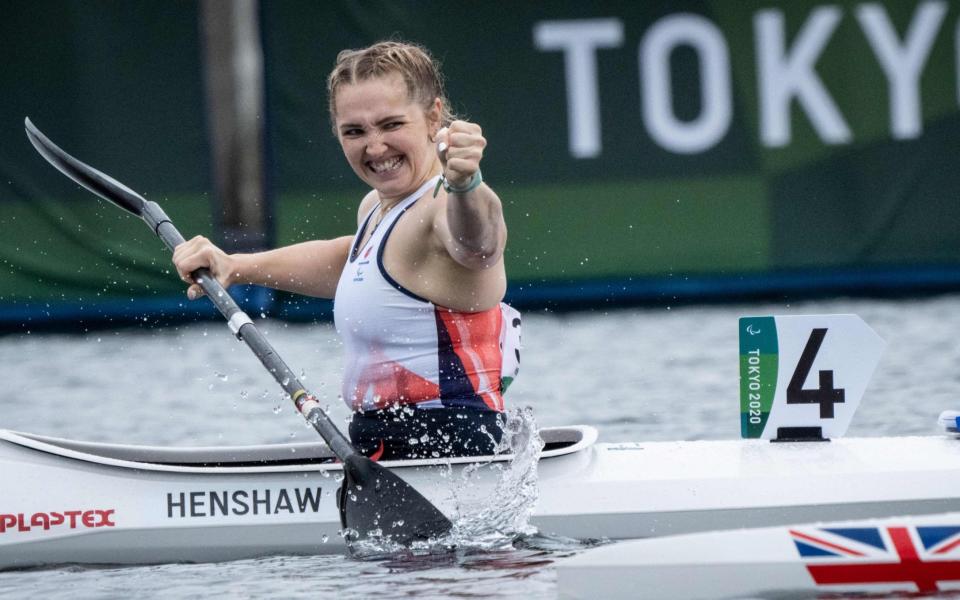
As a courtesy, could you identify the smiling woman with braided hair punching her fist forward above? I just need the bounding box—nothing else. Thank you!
[173,41,519,460]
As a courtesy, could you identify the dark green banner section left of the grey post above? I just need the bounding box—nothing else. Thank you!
[0,0,212,328]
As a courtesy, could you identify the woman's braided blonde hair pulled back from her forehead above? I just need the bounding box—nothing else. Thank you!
[327,41,455,135]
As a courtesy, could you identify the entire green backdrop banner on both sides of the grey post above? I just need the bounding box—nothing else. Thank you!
[0,0,960,328]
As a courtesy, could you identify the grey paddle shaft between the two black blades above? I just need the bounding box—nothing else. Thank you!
[146,200,356,460]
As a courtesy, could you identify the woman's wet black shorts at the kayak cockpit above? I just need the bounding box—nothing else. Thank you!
[350,407,503,460]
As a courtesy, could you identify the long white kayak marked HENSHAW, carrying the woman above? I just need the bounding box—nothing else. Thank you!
[0,426,960,569]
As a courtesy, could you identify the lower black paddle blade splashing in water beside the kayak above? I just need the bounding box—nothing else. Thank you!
[340,454,453,546]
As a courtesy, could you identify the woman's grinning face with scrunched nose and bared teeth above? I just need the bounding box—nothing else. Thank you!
[335,74,440,202]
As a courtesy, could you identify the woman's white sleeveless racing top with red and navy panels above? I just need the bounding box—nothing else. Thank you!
[333,177,520,411]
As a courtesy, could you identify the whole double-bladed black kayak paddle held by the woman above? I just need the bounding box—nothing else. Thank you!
[24,118,452,546]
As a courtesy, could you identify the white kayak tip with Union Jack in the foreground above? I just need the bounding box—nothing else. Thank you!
[557,512,960,600]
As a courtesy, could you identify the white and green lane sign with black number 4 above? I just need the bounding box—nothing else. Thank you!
[740,315,886,439]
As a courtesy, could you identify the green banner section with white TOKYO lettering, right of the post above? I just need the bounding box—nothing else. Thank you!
[264,0,960,288]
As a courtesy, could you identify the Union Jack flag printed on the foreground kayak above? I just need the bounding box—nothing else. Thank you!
[790,525,960,592]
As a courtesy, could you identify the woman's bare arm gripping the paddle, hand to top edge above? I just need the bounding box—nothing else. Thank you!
[173,236,353,299]
